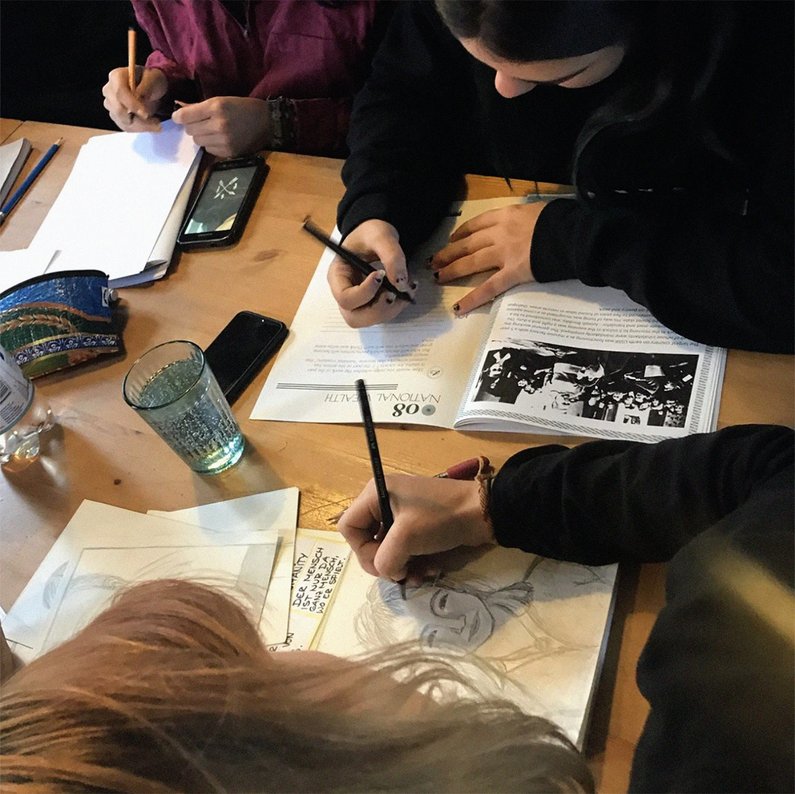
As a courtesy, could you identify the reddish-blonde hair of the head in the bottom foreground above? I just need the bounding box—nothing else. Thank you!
[0,580,593,794]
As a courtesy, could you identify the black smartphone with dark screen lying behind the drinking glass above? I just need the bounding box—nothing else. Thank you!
[204,312,287,405]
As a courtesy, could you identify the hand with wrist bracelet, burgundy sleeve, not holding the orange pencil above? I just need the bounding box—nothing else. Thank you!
[171,96,270,157]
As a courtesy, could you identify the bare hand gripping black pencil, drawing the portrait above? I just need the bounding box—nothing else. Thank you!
[337,474,495,583]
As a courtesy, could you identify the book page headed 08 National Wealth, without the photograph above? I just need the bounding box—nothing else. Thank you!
[251,197,522,427]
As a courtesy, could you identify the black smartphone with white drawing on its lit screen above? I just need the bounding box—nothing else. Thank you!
[177,155,269,249]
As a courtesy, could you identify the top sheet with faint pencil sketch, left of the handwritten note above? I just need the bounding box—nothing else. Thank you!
[8,500,278,662]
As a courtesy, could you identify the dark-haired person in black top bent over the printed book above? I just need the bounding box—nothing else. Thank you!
[329,0,795,352]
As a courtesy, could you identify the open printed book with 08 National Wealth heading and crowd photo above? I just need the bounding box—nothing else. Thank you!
[251,199,726,441]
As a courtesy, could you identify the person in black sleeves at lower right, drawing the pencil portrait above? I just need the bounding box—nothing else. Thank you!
[338,425,795,792]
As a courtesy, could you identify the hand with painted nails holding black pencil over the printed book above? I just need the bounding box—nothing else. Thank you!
[328,218,417,328]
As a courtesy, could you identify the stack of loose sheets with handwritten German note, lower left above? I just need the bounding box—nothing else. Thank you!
[3,488,348,662]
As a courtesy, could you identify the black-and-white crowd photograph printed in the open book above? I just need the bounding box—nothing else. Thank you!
[472,342,698,427]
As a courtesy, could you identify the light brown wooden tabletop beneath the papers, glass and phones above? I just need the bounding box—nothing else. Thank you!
[0,120,795,792]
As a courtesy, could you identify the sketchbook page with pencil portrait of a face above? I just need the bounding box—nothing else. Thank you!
[313,546,617,748]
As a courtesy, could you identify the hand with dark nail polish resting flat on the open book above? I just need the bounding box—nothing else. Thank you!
[430,201,546,315]
